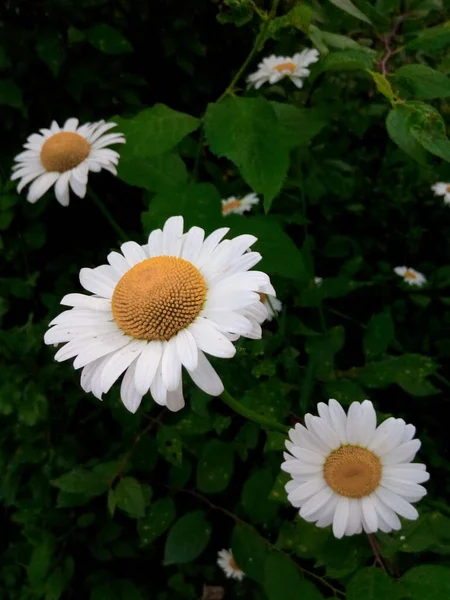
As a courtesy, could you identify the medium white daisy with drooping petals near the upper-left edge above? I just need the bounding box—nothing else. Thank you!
[11,119,125,206]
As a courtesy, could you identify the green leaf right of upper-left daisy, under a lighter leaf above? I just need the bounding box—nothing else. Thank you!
[118,152,188,192]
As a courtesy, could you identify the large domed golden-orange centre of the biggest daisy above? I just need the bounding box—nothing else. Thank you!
[111,256,206,340]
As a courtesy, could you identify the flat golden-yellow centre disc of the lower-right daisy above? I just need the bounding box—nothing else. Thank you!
[324,446,382,498]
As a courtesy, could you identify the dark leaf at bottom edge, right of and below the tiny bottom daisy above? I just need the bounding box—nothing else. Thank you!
[264,552,324,600]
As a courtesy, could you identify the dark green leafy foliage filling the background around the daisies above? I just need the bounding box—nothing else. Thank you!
[0,0,450,600]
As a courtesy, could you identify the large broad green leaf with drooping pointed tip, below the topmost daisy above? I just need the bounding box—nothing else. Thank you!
[205,96,289,212]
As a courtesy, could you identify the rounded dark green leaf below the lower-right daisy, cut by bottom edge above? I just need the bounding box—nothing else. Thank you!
[346,567,399,600]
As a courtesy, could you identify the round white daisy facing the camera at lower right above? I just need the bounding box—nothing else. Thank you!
[281,400,429,538]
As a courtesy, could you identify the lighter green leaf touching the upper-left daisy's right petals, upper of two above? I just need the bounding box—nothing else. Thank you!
[113,104,200,161]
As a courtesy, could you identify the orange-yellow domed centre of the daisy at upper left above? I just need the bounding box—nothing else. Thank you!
[41,131,91,173]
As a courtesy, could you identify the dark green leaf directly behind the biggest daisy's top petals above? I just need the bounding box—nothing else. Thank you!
[141,183,221,233]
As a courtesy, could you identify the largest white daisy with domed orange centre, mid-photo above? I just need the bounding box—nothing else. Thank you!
[44,217,275,412]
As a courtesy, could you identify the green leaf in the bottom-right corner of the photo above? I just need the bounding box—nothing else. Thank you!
[400,565,450,600]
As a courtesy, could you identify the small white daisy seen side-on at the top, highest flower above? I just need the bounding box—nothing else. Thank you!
[247,48,319,89]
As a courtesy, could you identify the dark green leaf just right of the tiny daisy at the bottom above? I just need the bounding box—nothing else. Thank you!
[231,524,269,583]
